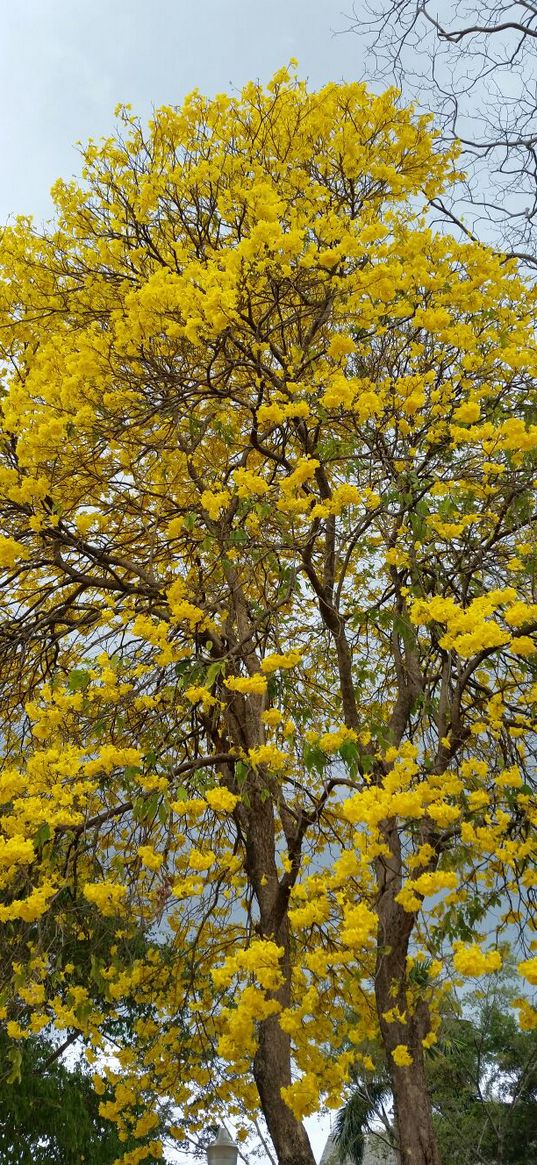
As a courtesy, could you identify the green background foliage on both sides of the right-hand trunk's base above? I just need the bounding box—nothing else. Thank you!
[335,973,537,1165]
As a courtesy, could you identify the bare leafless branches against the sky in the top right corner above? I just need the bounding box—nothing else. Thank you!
[347,0,537,271]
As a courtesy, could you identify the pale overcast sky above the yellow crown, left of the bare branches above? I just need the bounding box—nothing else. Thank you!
[0,0,362,223]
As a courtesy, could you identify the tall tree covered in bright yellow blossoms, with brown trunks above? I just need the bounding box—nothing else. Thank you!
[0,70,537,1165]
